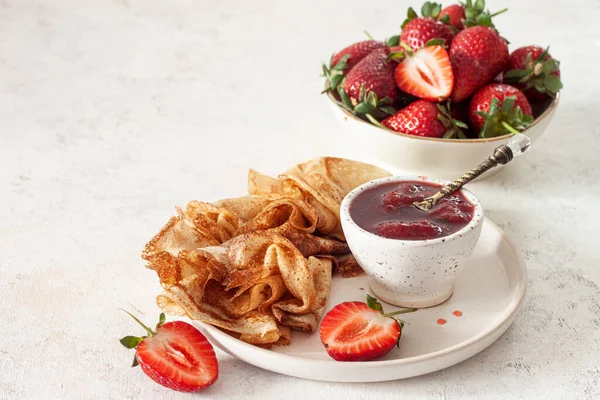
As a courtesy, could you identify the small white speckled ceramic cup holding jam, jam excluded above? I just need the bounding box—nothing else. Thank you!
[340,176,483,308]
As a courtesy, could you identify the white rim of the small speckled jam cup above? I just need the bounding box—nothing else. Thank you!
[340,175,484,247]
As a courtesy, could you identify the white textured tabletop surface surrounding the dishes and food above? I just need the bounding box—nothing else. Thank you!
[0,0,600,399]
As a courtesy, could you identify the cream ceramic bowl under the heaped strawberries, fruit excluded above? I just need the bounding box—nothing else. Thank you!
[328,93,560,180]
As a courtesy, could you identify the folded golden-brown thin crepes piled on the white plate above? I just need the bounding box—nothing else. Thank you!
[142,157,390,346]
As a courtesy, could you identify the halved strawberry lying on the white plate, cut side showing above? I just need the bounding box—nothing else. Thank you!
[320,295,416,361]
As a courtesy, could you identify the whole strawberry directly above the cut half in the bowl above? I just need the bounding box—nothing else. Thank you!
[400,1,454,50]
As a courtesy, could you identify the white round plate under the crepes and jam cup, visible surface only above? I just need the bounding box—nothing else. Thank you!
[194,219,527,382]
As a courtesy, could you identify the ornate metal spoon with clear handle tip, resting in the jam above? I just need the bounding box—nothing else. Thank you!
[413,133,531,211]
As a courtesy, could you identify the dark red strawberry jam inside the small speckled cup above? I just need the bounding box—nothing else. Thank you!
[350,181,475,240]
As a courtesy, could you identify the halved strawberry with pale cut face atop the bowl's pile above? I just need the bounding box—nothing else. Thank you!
[394,46,454,101]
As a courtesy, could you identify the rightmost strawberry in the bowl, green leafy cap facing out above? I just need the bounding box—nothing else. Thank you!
[504,46,562,102]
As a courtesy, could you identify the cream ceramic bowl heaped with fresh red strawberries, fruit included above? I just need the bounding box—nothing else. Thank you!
[323,0,562,179]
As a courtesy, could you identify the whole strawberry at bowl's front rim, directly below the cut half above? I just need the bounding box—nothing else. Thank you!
[381,100,467,138]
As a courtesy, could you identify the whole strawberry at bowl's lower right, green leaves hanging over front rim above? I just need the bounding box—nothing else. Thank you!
[469,83,533,137]
